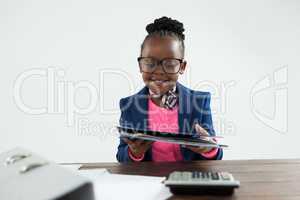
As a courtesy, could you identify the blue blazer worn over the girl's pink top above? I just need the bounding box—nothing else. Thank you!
[116,82,223,162]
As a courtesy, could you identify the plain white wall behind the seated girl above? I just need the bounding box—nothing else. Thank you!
[0,0,300,162]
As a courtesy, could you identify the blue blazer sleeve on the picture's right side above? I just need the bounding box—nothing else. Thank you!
[195,92,223,160]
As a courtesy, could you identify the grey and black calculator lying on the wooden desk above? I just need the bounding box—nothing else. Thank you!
[164,171,240,195]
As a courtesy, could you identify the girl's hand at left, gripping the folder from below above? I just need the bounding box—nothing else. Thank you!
[123,138,153,157]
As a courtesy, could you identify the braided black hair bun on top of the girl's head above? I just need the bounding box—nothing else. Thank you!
[146,17,184,40]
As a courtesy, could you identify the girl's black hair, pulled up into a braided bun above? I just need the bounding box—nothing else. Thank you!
[141,16,185,56]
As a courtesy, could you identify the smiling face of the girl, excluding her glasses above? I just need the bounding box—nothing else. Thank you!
[141,36,186,95]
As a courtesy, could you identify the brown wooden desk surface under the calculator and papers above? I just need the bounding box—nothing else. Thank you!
[81,159,300,200]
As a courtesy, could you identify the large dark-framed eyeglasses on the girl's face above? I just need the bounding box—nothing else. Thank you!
[138,57,183,74]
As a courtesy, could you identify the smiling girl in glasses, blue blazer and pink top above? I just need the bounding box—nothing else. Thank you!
[117,17,223,162]
